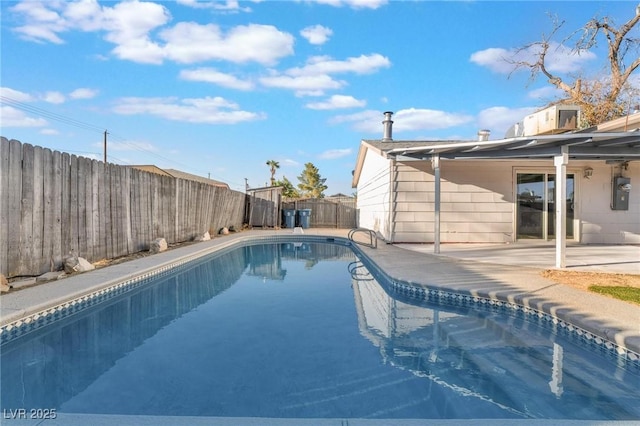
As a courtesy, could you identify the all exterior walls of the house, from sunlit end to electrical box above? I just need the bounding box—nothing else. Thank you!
[358,151,640,244]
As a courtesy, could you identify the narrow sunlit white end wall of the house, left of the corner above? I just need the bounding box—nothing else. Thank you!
[356,151,392,239]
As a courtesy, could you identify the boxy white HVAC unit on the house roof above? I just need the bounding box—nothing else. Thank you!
[522,105,580,136]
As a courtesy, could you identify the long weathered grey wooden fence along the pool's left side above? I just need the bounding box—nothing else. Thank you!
[0,137,245,277]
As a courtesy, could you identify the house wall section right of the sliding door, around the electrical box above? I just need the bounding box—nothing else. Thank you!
[579,161,640,244]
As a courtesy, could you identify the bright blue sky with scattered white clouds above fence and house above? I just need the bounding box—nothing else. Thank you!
[0,0,637,195]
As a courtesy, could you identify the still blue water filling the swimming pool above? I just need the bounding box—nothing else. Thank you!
[0,243,640,420]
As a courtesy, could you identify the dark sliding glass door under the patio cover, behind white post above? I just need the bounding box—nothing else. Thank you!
[516,173,575,240]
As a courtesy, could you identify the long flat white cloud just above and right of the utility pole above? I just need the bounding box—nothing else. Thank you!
[113,97,266,124]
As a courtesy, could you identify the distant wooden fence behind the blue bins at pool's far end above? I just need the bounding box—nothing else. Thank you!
[282,198,358,229]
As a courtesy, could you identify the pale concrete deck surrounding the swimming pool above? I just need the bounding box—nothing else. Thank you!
[0,229,640,425]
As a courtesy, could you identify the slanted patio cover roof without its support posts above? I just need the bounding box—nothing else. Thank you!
[363,129,640,161]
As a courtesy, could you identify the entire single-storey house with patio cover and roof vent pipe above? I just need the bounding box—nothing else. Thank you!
[352,112,640,260]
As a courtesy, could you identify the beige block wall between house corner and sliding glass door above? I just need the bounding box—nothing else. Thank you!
[393,160,515,243]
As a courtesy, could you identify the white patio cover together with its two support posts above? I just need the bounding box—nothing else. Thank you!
[354,129,640,268]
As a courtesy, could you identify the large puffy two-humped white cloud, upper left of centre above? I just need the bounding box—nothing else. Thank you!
[160,22,294,65]
